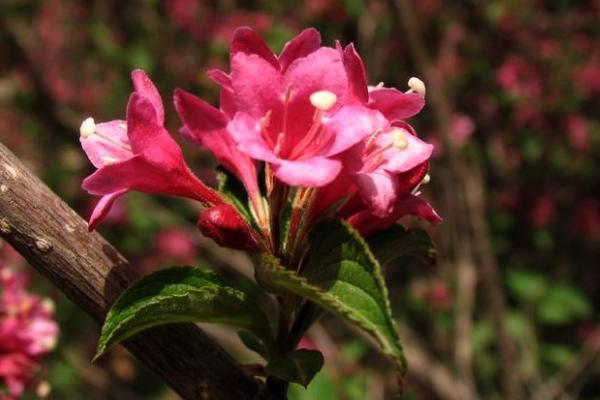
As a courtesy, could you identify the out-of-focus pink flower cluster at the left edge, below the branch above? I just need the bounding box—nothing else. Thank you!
[0,245,58,400]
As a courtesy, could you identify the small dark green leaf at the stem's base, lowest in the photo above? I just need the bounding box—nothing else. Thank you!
[265,349,323,387]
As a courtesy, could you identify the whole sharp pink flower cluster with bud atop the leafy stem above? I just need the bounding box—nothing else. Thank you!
[80,28,440,254]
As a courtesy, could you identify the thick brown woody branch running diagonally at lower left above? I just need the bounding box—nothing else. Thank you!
[0,144,269,400]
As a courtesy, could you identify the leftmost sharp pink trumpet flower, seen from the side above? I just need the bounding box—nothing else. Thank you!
[81,70,223,229]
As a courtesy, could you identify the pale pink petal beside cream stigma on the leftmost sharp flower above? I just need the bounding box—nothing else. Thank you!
[79,120,133,168]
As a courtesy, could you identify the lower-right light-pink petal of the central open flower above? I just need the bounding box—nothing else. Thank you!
[321,105,388,157]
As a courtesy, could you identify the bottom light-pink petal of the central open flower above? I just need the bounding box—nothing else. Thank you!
[275,157,342,187]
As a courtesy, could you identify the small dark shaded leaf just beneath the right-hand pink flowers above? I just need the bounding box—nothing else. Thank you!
[367,225,436,265]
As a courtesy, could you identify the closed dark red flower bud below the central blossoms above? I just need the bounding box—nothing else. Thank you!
[198,204,258,250]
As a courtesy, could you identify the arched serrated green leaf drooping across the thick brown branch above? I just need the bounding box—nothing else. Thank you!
[96,267,270,357]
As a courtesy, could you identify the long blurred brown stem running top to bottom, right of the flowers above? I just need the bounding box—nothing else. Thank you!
[389,0,521,400]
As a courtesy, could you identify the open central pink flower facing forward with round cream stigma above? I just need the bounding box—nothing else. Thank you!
[206,28,378,187]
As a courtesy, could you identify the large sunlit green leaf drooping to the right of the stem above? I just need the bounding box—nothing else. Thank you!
[262,220,406,374]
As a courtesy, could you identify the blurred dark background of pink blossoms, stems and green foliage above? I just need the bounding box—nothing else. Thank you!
[0,0,600,400]
